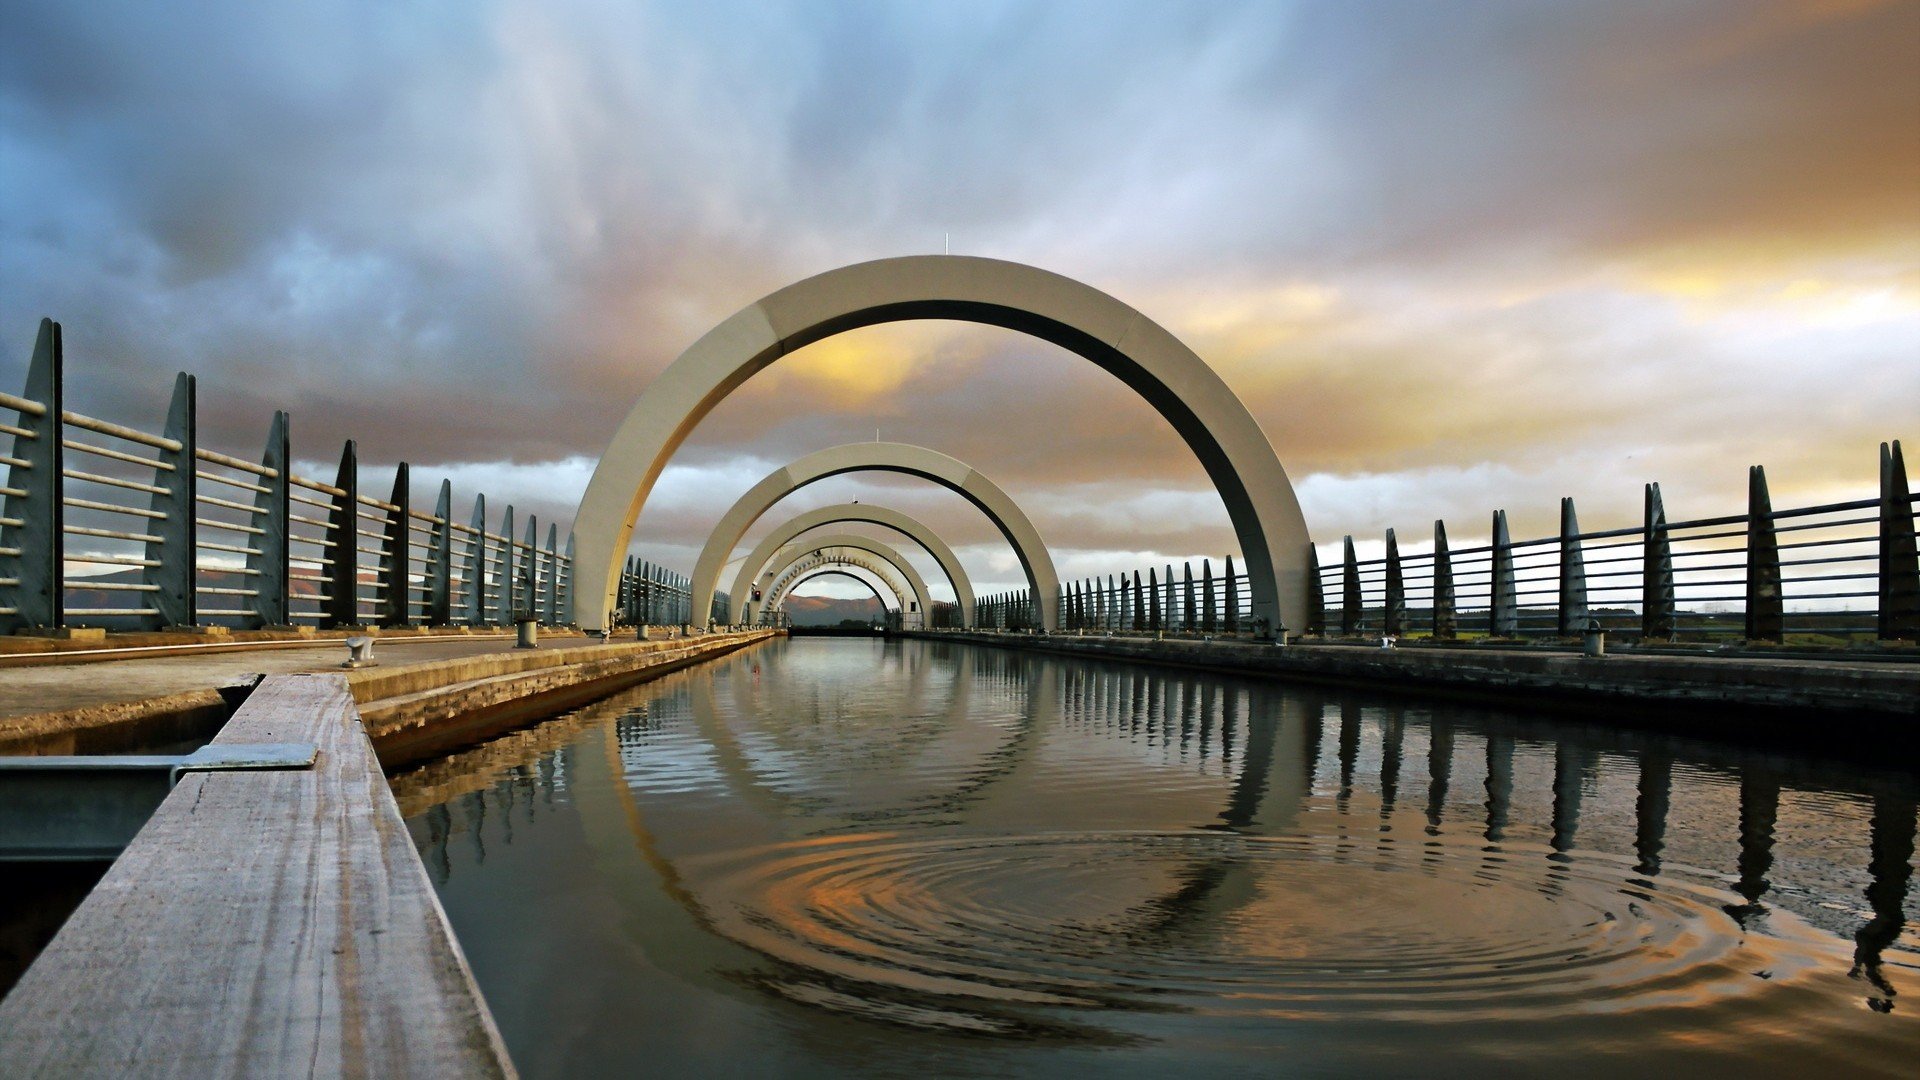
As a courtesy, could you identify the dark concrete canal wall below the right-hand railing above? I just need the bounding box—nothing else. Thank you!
[904,630,1920,742]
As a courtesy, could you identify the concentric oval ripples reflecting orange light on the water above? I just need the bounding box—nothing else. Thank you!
[687,832,1832,1026]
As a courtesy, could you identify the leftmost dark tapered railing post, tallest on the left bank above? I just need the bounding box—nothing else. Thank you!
[0,319,67,630]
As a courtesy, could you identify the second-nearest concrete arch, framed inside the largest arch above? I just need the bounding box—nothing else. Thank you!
[687,442,1060,626]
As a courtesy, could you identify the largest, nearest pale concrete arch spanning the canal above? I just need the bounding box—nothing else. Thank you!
[574,256,1311,630]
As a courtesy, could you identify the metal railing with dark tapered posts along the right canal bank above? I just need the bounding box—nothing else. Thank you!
[1044,440,1920,646]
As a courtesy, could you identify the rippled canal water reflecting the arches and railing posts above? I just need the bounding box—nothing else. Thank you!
[394,638,1920,1078]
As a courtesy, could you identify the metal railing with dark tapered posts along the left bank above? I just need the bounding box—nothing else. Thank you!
[0,319,685,632]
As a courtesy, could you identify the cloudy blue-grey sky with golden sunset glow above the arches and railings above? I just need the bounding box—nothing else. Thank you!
[0,0,1920,596]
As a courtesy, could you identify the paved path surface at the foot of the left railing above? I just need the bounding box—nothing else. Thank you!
[0,634,541,717]
